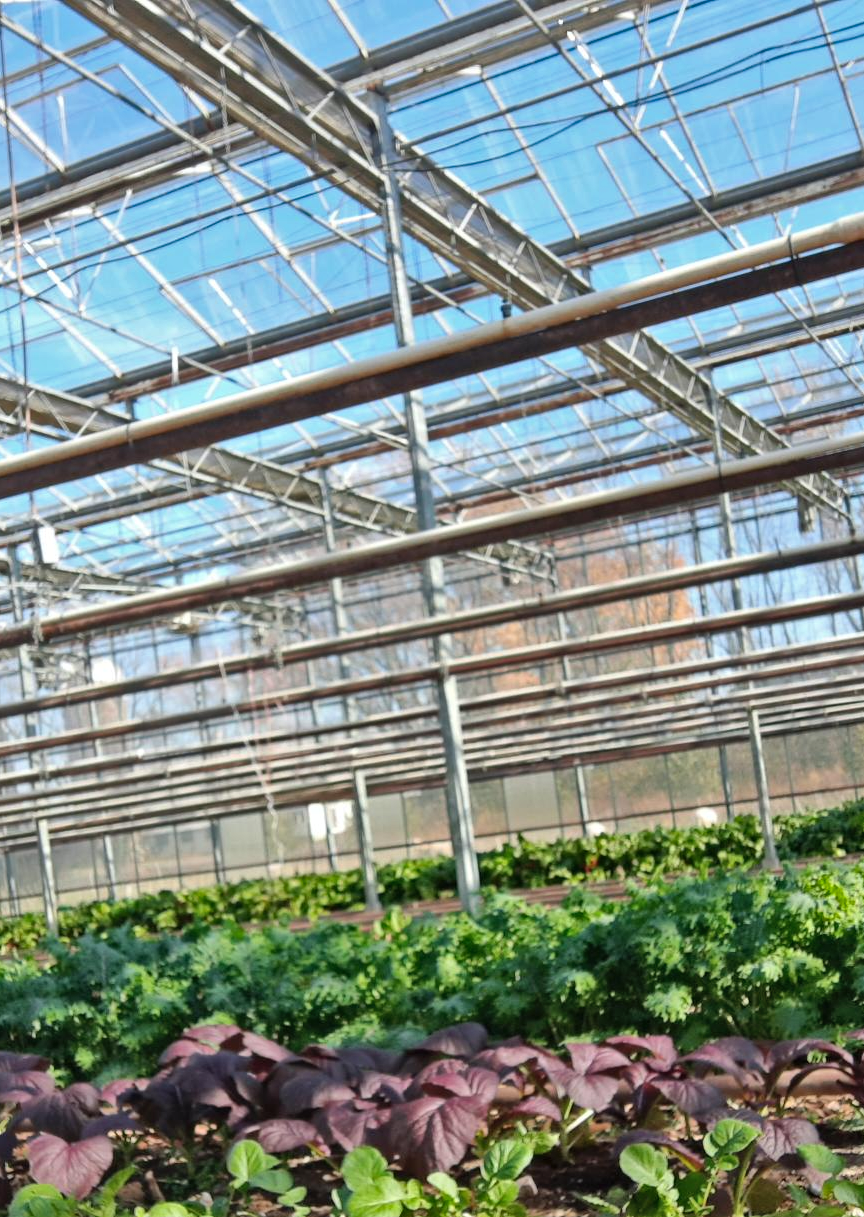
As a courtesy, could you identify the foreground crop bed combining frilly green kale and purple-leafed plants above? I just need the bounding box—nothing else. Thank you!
[0,827,864,1217]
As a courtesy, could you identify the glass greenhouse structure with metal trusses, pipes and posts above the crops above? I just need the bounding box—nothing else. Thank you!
[0,0,864,920]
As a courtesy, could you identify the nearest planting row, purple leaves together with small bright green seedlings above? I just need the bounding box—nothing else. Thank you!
[0,1022,864,1217]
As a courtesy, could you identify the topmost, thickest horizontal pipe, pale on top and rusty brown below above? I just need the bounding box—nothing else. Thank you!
[0,221,864,498]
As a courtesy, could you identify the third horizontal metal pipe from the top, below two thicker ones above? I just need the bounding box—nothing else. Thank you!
[0,537,864,718]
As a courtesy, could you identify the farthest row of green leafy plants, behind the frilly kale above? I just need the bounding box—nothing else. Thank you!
[0,801,864,950]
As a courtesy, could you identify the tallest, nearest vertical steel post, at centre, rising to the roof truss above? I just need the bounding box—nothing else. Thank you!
[370,91,479,914]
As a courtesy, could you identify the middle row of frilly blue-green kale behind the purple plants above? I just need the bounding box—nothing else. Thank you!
[0,863,864,1079]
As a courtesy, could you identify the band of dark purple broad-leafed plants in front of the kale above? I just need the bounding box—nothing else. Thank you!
[0,1022,864,1196]
